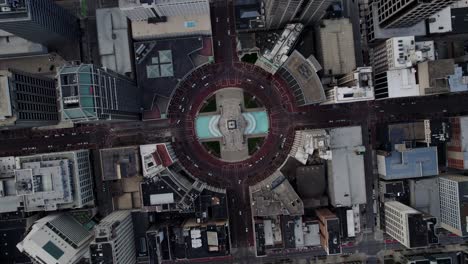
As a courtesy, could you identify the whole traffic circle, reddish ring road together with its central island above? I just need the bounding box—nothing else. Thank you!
[167,63,294,186]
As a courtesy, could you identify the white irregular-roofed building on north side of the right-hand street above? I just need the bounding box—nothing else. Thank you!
[322,67,375,104]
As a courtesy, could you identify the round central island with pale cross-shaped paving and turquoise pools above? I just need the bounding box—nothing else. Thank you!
[195,88,269,162]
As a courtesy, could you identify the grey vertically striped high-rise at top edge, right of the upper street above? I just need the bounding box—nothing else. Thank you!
[265,0,333,29]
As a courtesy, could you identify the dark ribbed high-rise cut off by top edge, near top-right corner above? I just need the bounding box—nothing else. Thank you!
[377,0,455,28]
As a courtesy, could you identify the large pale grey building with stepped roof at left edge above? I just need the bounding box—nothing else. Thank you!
[0,150,94,213]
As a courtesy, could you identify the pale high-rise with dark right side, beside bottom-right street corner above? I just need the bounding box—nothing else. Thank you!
[385,201,429,248]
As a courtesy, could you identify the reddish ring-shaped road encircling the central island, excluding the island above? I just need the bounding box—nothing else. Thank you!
[168,63,294,188]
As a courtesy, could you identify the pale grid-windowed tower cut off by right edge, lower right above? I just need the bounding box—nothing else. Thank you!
[439,175,468,237]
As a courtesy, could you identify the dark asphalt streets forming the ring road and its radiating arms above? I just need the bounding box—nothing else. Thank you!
[0,0,468,263]
